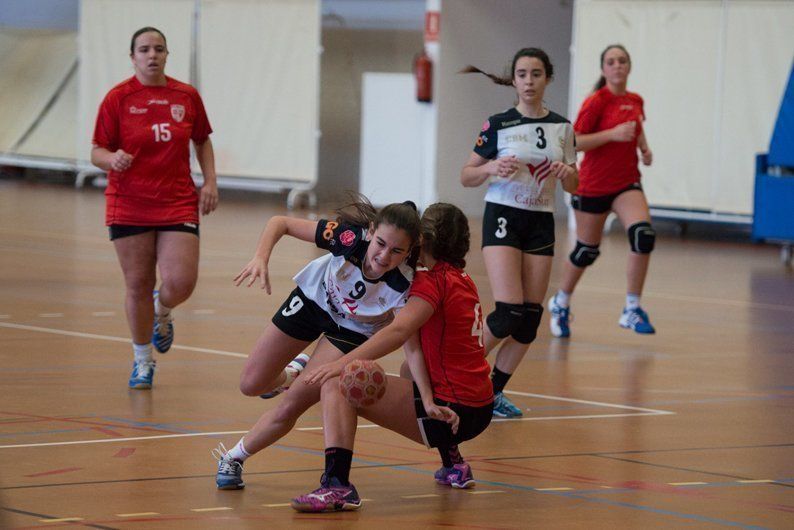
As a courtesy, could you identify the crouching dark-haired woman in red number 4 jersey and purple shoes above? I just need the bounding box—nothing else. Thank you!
[292,203,493,512]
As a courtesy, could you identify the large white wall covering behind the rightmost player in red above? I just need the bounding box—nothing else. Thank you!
[572,0,794,214]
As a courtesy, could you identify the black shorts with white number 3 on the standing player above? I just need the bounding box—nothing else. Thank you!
[482,202,554,256]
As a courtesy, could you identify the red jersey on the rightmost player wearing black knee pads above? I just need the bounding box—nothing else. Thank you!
[573,87,645,197]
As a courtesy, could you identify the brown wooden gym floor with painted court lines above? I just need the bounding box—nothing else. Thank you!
[0,180,794,529]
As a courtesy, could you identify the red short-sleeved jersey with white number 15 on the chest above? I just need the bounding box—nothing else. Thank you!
[94,77,212,226]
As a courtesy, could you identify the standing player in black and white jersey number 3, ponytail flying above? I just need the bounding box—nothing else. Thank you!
[460,48,579,418]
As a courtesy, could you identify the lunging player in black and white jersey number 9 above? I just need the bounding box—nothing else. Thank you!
[213,197,420,489]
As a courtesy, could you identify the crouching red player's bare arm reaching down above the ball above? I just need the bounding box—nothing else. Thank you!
[304,296,433,385]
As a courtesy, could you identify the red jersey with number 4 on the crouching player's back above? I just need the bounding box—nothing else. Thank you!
[409,261,493,407]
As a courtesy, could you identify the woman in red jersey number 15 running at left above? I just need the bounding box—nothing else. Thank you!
[91,27,218,389]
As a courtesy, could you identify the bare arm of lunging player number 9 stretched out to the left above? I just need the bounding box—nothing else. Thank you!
[234,215,317,294]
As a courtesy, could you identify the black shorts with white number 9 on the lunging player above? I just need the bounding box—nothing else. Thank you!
[273,287,368,353]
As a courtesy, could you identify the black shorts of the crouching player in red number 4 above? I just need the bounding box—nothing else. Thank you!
[414,383,493,447]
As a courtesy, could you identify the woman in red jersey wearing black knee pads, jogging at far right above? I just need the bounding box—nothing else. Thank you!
[549,44,656,337]
